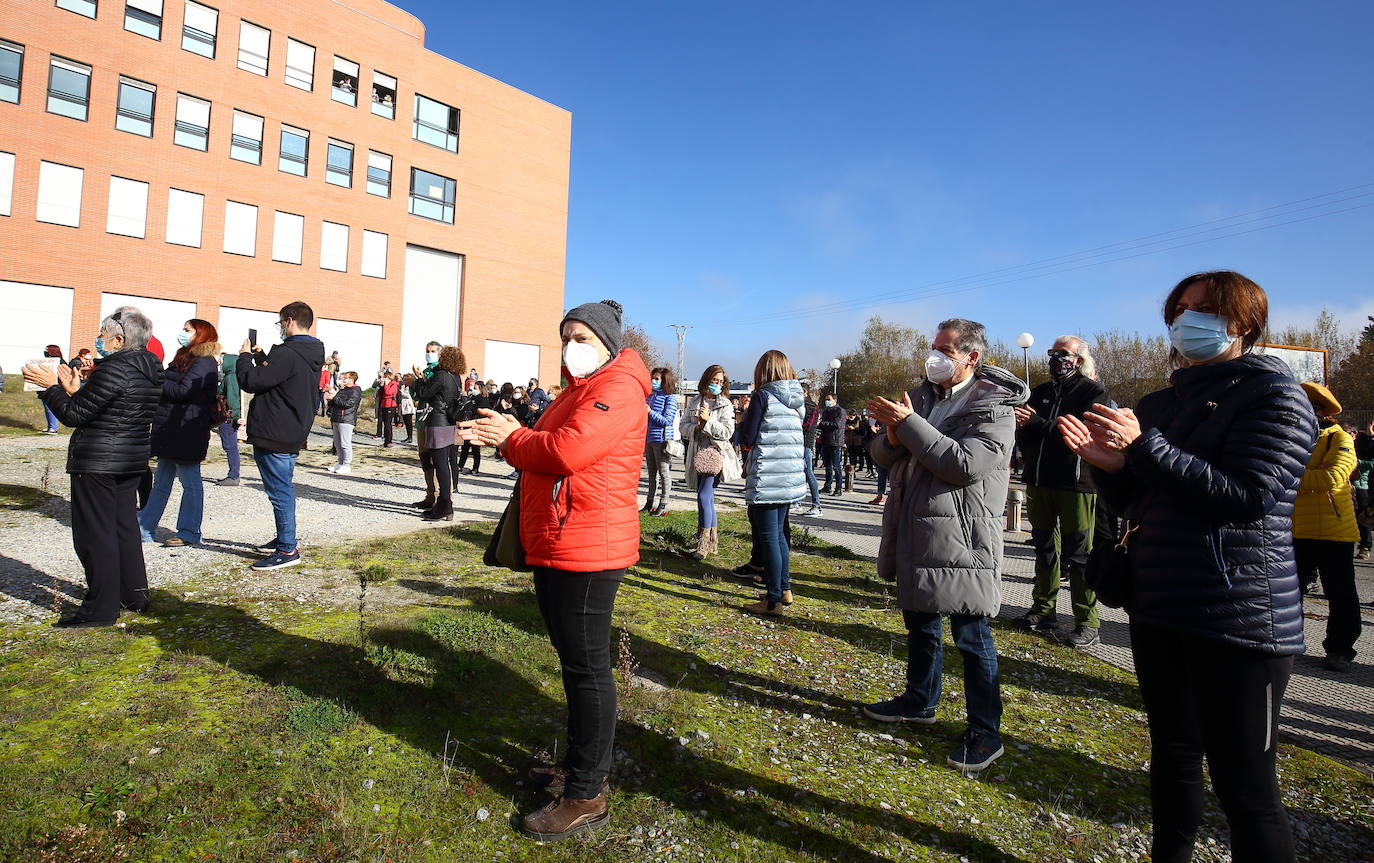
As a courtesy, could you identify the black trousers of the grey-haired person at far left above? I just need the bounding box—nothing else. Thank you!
[71,474,148,621]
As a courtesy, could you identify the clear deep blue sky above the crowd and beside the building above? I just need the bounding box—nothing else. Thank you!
[401,0,1374,378]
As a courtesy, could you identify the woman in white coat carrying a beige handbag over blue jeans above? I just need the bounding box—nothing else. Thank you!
[679,366,743,561]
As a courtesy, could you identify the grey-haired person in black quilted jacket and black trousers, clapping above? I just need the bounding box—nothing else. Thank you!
[23,311,162,627]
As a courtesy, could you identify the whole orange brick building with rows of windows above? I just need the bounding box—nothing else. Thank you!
[0,0,572,383]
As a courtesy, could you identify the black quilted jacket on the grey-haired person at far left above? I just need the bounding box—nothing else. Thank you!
[43,349,162,474]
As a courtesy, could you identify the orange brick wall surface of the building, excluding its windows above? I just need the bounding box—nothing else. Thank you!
[0,0,572,379]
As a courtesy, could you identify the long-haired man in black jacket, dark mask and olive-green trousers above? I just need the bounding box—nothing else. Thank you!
[1017,335,1107,647]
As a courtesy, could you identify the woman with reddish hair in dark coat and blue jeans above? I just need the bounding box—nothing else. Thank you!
[139,319,224,548]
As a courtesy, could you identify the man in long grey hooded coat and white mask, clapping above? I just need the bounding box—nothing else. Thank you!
[864,317,1029,772]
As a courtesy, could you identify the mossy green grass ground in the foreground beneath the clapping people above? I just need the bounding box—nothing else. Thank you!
[0,513,1374,863]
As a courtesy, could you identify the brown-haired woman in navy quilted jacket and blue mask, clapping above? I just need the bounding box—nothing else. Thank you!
[1059,271,1316,863]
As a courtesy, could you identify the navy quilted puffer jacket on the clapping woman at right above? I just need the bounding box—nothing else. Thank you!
[1092,355,1316,655]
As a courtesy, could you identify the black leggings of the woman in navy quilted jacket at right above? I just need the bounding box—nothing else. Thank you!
[1131,621,1294,863]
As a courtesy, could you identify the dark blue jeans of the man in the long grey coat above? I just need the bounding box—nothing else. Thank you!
[901,610,1002,741]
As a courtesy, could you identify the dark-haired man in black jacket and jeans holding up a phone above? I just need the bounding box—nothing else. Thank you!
[236,302,324,570]
